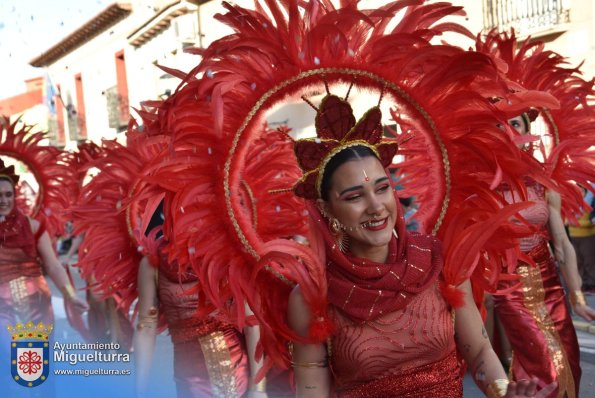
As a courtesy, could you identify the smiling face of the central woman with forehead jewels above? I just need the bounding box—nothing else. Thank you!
[319,156,397,257]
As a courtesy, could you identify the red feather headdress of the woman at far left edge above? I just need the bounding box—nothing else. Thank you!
[0,117,76,237]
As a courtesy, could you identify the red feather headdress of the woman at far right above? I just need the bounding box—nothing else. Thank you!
[476,30,595,220]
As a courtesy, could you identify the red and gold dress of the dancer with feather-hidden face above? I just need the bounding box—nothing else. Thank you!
[157,244,249,398]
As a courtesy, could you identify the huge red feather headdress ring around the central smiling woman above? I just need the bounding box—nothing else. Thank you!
[151,0,560,374]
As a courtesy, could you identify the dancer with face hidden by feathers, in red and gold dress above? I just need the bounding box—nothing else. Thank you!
[134,208,250,398]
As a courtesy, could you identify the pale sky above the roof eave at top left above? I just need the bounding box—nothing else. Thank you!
[0,0,115,99]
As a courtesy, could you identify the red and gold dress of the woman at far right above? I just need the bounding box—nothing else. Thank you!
[494,184,581,397]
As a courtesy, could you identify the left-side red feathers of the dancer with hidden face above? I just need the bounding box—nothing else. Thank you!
[71,131,166,313]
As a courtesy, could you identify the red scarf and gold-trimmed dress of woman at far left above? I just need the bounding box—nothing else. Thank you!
[0,209,54,325]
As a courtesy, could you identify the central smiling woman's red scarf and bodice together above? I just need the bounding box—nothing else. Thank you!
[328,230,463,398]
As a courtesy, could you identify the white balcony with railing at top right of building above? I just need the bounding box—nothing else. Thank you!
[483,0,570,36]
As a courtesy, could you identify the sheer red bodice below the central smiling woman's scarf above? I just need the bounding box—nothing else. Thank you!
[331,283,461,397]
